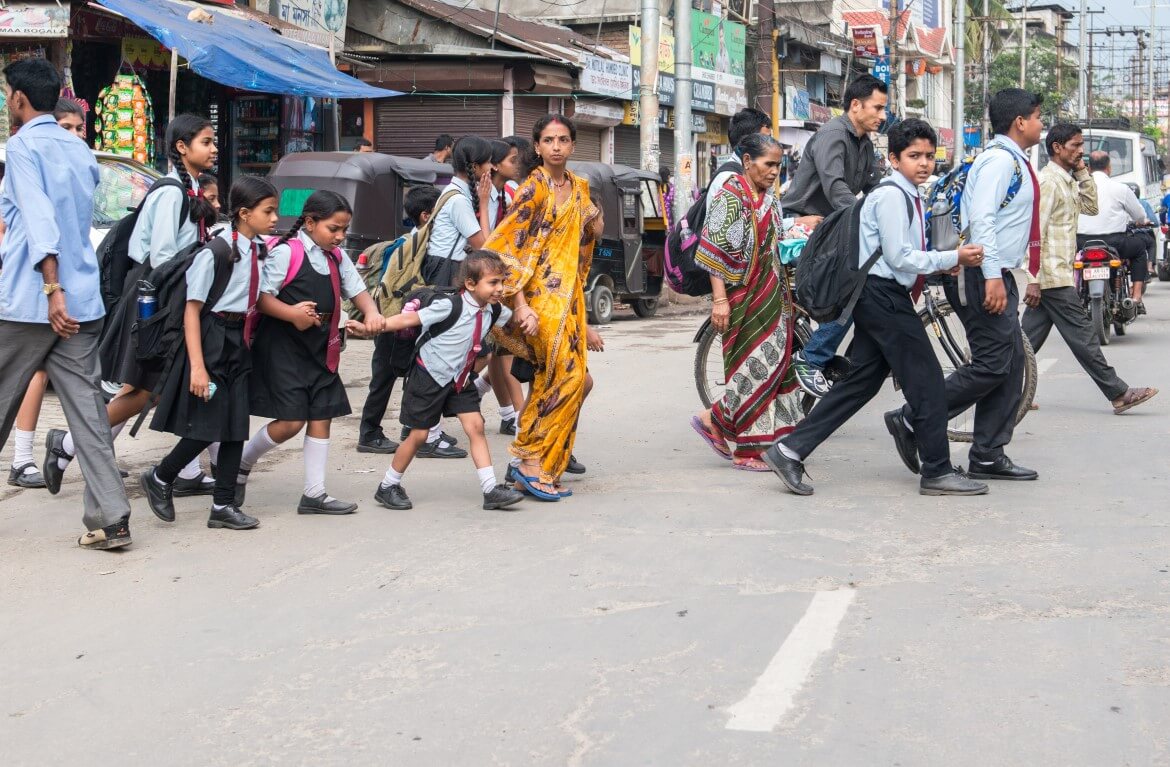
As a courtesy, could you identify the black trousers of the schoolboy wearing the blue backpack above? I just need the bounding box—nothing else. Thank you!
[902,269,1024,462]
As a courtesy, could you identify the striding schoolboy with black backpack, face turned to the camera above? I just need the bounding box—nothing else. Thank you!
[763,119,987,496]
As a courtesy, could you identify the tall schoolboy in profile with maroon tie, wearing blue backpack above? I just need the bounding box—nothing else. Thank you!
[887,88,1044,481]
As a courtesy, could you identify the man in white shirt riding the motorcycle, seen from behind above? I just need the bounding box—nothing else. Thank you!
[1076,150,1151,315]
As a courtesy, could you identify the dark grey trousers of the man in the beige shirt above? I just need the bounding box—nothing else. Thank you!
[1020,288,1129,401]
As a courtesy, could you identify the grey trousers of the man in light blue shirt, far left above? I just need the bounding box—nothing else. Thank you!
[0,319,130,530]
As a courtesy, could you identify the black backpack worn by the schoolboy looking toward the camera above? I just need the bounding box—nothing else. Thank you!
[796,181,915,326]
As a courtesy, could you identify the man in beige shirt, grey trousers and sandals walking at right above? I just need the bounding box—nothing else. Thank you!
[1020,123,1158,415]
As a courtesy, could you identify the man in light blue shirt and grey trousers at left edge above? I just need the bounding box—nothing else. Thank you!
[0,58,130,548]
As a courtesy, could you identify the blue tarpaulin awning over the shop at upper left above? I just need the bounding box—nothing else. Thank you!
[96,0,401,98]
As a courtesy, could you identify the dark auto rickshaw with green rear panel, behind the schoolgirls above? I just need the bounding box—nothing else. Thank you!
[268,152,452,260]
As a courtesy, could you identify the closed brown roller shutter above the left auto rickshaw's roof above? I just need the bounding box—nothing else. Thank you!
[374,96,501,158]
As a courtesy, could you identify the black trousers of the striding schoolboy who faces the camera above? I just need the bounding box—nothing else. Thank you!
[782,275,951,477]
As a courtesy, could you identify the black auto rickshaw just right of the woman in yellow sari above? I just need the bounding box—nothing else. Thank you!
[569,163,666,325]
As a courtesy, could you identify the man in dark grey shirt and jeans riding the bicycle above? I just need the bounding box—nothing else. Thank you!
[783,75,888,398]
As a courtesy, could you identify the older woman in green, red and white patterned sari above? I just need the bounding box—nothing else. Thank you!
[691,134,804,471]
